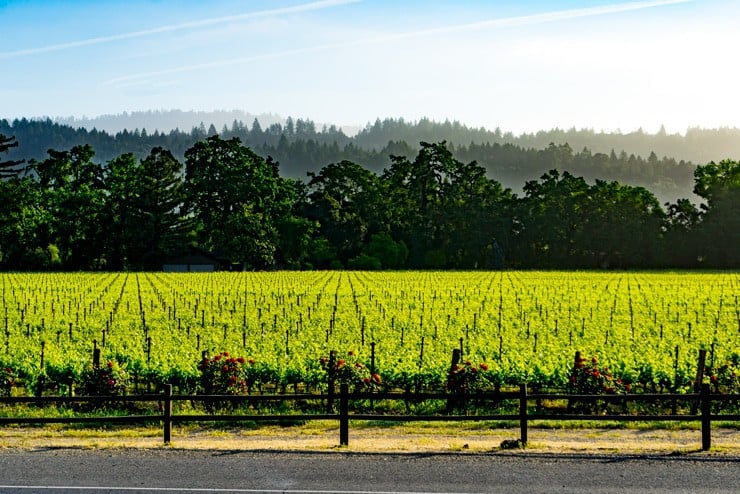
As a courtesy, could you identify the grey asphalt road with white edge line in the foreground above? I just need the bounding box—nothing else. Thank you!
[0,448,740,494]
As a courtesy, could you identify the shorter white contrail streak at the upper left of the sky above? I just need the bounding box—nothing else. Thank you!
[0,0,360,60]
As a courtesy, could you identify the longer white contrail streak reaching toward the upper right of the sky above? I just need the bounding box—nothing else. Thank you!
[107,0,693,87]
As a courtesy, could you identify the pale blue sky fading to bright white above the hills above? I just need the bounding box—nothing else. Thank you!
[0,0,740,133]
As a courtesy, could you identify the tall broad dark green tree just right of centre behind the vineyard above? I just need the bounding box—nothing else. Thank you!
[383,141,510,269]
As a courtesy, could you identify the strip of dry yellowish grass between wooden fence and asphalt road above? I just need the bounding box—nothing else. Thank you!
[0,424,740,458]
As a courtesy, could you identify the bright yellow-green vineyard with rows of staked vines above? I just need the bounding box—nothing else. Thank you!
[0,271,740,394]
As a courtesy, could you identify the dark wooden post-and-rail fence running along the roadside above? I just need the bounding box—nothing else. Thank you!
[0,384,740,451]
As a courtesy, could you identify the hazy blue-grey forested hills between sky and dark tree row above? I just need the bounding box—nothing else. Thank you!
[0,112,740,202]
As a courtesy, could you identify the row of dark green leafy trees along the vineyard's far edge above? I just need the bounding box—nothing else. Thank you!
[0,134,740,270]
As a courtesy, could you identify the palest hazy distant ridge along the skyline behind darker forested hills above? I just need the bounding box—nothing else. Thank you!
[44,110,740,164]
